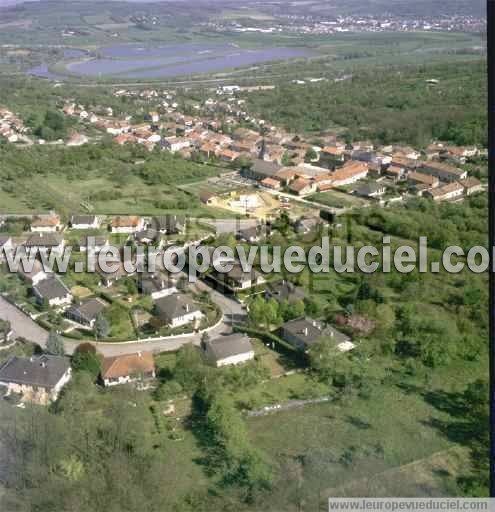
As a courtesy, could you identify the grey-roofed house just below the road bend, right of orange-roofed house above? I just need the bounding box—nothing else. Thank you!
[202,333,254,368]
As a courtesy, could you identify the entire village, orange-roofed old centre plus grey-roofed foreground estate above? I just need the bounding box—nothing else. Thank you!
[0,86,484,403]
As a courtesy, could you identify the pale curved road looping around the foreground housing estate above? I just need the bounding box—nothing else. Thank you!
[0,281,245,357]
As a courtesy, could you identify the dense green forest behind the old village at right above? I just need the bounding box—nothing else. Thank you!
[247,60,487,148]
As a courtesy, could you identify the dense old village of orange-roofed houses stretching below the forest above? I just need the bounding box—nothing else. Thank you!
[59,86,481,206]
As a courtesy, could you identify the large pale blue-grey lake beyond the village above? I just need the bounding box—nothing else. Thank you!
[67,43,312,78]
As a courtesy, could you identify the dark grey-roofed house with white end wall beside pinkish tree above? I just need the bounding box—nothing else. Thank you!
[279,317,354,351]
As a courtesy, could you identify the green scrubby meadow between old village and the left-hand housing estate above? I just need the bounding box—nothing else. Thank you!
[0,147,238,218]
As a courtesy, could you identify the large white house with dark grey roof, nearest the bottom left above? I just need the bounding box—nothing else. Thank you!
[0,355,72,405]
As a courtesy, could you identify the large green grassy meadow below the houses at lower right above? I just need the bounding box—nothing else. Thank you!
[247,360,487,511]
